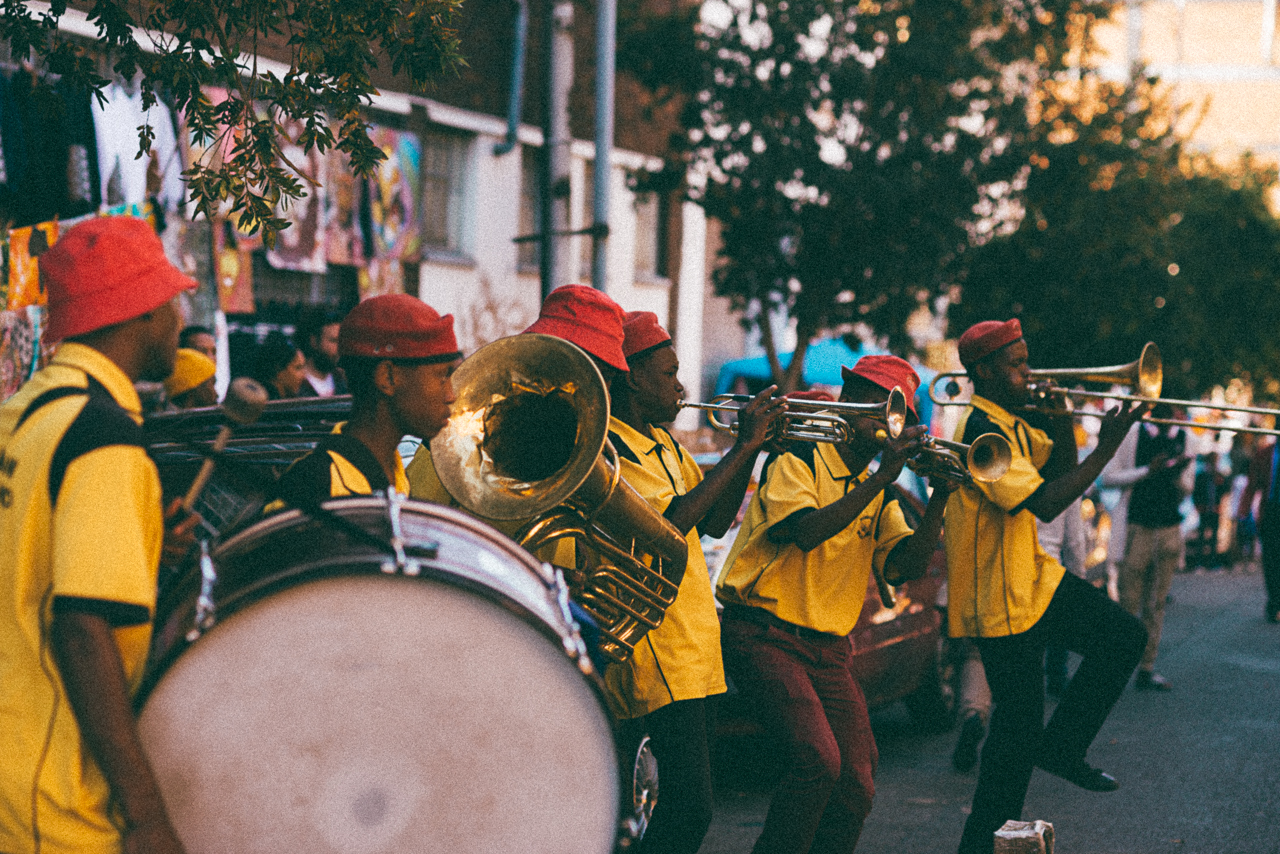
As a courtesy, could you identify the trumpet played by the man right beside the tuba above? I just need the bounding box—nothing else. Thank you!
[680,385,908,443]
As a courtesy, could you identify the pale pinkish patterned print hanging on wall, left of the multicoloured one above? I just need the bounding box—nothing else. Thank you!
[266,120,329,273]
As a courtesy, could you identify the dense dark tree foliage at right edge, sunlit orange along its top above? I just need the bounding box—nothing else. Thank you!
[950,69,1280,396]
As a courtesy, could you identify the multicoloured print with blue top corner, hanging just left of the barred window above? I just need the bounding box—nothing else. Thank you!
[369,121,422,293]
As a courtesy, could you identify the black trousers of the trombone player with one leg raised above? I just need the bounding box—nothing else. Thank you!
[960,572,1147,854]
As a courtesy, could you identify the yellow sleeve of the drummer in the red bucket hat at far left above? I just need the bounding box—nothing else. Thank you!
[52,446,164,613]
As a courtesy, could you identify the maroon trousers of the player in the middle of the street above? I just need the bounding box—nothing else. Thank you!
[721,615,879,854]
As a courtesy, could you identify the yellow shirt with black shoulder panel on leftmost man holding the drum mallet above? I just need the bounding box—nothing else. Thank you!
[0,342,164,854]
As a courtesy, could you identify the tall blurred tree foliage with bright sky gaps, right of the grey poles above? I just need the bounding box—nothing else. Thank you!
[689,0,1105,385]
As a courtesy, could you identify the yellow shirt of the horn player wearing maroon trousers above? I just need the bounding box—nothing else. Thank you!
[716,443,911,635]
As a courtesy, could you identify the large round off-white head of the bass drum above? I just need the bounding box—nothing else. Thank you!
[140,576,618,854]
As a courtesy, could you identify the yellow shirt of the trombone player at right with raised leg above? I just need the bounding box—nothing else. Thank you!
[942,396,1066,638]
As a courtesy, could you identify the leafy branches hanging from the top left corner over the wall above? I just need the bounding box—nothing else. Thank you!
[0,0,462,239]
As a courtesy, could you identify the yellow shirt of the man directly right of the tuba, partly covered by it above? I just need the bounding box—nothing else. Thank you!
[604,419,726,718]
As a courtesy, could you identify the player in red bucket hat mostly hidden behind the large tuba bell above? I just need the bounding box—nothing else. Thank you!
[408,284,627,555]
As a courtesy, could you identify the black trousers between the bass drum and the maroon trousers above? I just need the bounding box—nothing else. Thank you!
[639,698,714,854]
